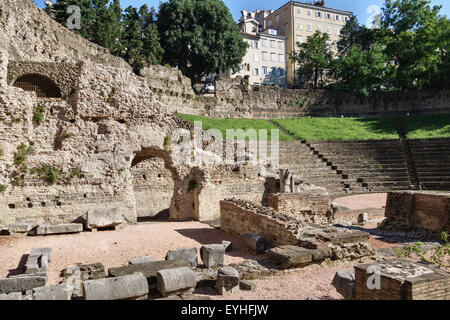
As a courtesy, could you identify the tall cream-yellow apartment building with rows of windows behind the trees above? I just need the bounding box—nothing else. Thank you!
[265,0,353,87]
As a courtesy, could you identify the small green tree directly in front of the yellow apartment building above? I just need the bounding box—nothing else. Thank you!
[291,31,333,89]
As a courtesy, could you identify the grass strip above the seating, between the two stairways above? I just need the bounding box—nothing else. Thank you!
[274,117,399,141]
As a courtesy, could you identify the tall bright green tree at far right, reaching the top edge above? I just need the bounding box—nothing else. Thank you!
[378,0,445,90]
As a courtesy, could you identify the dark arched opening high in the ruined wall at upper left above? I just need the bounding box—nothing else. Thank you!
[14,74,61,98]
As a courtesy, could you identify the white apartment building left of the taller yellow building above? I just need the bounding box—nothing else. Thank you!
[229,10,286,88]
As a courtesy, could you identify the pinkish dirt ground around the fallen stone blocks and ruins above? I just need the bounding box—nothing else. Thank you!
[0,194,391,300]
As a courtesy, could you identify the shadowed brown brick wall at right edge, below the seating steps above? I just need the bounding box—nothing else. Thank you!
[383,191,450,238]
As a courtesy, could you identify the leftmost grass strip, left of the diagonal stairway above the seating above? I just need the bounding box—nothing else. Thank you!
[178,114,293,141]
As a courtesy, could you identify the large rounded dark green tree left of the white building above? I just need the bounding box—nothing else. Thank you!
[158,0,247,83]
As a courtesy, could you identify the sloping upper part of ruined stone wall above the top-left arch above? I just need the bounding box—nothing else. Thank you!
[0,0,131,70]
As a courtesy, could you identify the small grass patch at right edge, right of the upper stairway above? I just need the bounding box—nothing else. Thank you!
[404,114,450,139]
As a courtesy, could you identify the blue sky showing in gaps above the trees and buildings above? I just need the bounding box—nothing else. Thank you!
[36,0,450,24]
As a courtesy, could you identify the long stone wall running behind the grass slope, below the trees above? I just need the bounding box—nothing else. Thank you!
[215,77,450,118]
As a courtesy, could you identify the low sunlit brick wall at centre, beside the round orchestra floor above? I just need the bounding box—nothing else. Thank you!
[269,189,332,223]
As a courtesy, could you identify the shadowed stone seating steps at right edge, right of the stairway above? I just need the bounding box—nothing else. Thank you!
[409,139,450,190]
